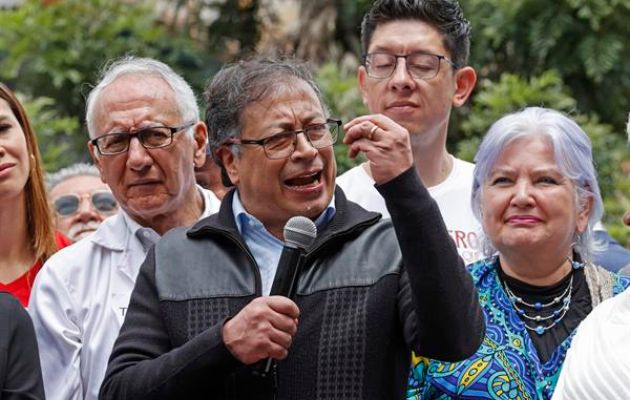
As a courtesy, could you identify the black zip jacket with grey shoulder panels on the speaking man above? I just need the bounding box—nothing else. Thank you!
[100,169,484,400]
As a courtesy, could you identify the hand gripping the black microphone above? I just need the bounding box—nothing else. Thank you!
[223,296,299,364]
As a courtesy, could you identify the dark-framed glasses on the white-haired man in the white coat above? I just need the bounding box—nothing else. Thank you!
[90,122,195,156]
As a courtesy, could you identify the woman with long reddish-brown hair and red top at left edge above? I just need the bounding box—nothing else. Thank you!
[0,83,70,307]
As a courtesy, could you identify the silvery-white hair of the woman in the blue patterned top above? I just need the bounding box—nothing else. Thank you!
[471,107,604,261]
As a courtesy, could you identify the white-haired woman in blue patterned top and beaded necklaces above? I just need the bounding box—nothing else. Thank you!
[408,107,630,399]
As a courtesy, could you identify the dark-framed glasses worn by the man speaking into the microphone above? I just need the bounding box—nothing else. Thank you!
[227,119,341,160]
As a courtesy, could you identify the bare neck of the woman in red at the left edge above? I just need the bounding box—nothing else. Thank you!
[0,192,35,284]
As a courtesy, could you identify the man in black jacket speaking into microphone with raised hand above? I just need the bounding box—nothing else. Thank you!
[100,58,484,400]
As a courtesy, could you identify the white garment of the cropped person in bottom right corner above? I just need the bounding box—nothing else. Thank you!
[552,289,630,400]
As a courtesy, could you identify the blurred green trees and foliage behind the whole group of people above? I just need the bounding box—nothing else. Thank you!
[0,0,630,246]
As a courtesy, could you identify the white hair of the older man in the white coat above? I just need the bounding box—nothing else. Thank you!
[85,56,199,138]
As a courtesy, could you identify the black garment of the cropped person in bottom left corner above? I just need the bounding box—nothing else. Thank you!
[0,292,45,400]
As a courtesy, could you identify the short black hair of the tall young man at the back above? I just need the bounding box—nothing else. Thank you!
[361,0,470,68]
